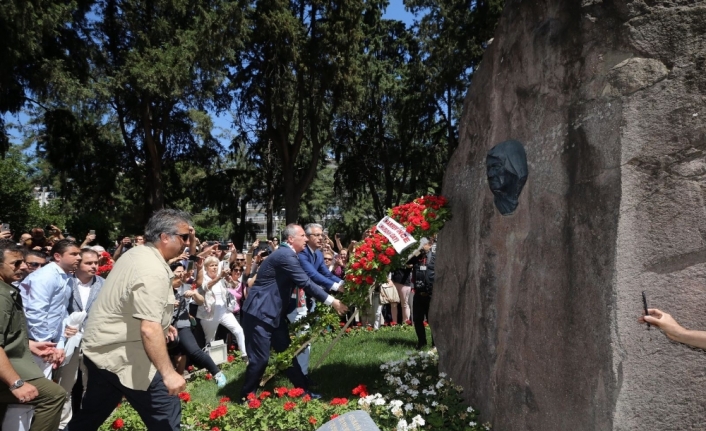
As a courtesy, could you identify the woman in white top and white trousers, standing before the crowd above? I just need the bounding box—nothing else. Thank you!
[196,256,247,359]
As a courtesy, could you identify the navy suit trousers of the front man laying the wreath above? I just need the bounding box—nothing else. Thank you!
[240,313,309,398]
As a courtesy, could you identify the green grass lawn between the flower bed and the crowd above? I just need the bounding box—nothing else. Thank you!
[187,325,431,406]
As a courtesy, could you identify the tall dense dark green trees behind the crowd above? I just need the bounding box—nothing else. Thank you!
[0,0,502,240]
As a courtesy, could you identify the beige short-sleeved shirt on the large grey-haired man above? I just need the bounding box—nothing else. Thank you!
[82,244,175,391]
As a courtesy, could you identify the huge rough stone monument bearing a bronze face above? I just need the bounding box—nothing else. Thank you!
[431,0,706,431]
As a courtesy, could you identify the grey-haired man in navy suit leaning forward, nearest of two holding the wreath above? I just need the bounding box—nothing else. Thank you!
[240,224,348,398]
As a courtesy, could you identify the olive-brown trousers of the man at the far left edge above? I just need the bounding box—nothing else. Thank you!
[0,377,66,431]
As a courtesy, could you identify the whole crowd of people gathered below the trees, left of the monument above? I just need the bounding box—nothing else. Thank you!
[0,210,434,431]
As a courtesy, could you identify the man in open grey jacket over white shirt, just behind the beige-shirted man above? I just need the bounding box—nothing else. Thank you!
[54,249,105,430]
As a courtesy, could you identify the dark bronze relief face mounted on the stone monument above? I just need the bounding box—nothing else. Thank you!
[485,140,527,215]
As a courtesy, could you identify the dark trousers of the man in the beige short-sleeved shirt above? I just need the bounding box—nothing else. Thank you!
[65,356,181,431]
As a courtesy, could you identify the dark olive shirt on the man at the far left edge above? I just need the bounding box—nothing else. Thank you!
[0,280,44,380]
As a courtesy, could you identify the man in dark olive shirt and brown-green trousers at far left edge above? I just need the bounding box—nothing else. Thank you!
[0,239,66,431]
